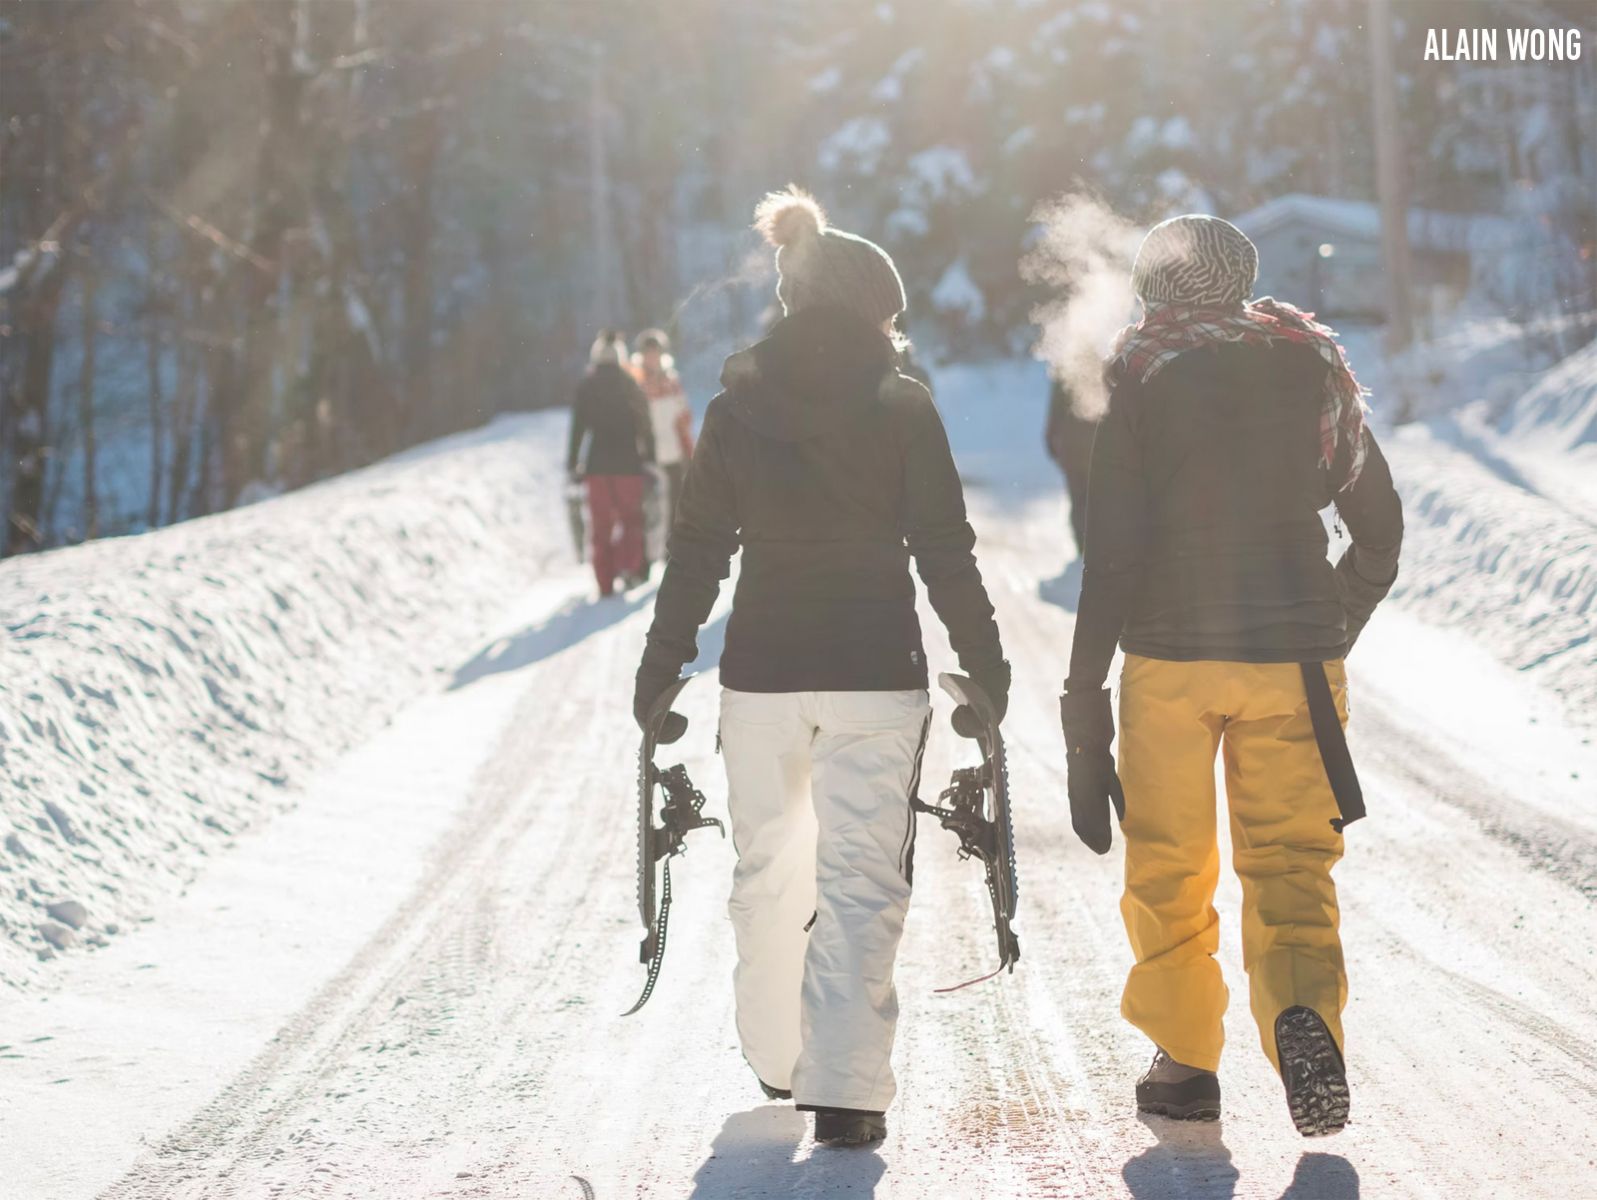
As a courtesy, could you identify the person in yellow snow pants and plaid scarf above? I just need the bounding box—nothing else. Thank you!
[1060,216,1402,1136]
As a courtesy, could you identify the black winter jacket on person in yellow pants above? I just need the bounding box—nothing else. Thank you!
[1067,342,1402,692]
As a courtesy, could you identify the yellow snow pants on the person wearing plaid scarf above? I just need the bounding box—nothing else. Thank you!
[1118,655,1348,1071]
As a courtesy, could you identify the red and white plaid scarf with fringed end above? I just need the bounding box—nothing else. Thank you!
[1104,296,1369,491]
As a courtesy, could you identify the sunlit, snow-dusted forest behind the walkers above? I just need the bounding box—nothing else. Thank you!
[0,0,1597,554]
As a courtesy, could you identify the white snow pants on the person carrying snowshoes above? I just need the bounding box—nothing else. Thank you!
[720,689,931,1112]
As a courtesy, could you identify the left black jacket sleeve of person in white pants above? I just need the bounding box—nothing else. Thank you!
[639,396,739,679]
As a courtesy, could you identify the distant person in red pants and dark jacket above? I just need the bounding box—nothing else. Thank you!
[565,329,655,596]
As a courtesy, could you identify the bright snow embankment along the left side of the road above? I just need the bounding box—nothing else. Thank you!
[0,414,572,986]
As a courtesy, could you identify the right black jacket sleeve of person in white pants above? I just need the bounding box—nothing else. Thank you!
[894,380,1005,679]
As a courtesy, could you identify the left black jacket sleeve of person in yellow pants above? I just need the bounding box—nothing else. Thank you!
[1065,382,1148,692]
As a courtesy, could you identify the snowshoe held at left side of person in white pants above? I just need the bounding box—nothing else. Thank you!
[621,676,727,1016]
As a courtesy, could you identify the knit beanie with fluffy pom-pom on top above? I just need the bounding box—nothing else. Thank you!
[754,185,907,324]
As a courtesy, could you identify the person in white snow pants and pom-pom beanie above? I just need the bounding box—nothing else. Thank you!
[632,190,1009,1144]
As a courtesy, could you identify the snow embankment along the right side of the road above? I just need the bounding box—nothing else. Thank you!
[1348,329,1597,729]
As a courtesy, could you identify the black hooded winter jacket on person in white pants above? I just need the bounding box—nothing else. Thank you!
[639,308,1006,692]
